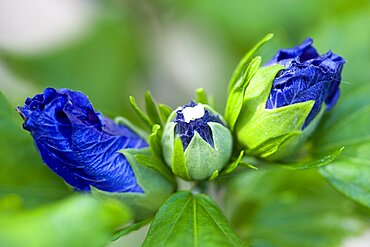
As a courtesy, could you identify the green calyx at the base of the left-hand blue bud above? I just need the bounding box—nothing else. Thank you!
[90,148,176,220]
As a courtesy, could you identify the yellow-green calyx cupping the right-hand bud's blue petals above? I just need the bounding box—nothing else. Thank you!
[235,65,314,158]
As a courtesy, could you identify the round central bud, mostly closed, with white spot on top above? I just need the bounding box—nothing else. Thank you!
[162,101,232,180]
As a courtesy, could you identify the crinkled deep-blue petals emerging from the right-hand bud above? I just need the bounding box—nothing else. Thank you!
[266,38,345,129]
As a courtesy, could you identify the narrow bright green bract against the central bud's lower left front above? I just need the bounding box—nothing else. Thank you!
[171,137,191,180]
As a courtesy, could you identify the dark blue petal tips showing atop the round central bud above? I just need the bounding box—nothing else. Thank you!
[174,101,224,150]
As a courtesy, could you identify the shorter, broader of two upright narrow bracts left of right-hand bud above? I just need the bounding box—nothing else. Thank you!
[225,57,261,131]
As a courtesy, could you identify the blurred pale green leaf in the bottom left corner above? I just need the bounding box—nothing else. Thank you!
[0,195,131,247]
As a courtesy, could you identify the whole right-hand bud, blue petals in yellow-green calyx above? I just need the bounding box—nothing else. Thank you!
[231,38,345,159]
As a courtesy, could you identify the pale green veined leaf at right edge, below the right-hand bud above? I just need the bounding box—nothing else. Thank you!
[319,143,370,208]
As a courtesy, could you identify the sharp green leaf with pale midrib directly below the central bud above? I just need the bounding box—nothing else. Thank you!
[143,191,245,247]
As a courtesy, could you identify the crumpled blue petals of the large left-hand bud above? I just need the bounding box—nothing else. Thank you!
[18,88,148,192]
